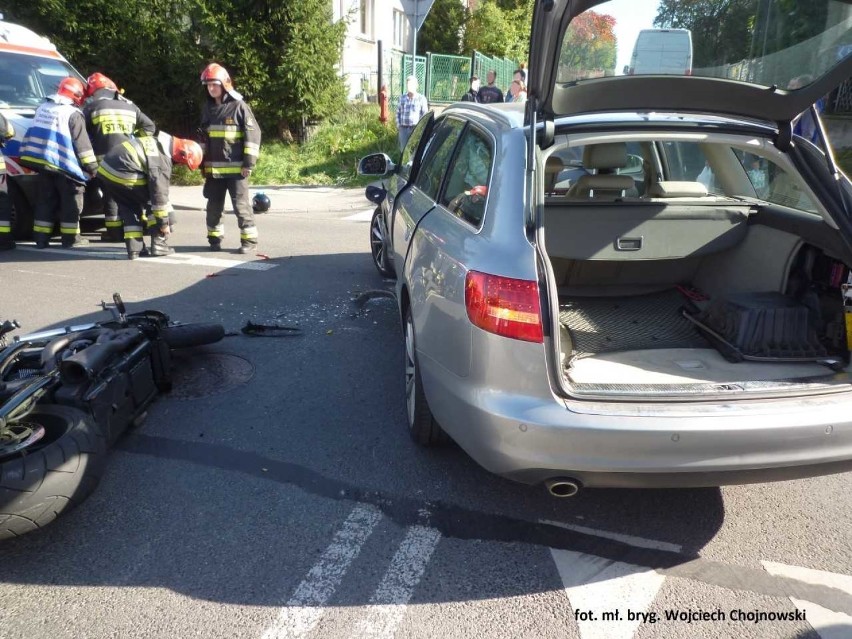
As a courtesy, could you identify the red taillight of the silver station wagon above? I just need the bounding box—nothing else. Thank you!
[464,271,543,343]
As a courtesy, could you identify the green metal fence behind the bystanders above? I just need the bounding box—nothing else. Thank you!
[384,51,518,109]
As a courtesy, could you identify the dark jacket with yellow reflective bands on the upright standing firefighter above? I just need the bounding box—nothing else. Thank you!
[201,93,260,178]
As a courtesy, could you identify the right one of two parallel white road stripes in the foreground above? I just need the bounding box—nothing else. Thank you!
[354,526,441,637]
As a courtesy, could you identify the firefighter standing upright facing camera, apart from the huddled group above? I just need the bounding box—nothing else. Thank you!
[201,63,260,254]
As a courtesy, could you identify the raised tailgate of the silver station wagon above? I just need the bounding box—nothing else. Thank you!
[528,0,852,129]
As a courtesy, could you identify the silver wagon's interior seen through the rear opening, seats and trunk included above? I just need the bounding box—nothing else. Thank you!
[542,134,852,397]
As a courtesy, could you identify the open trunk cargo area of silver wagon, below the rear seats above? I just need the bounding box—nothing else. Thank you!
[545,199,852,398]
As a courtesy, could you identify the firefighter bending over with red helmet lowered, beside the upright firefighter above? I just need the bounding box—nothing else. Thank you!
[98,131,203,260]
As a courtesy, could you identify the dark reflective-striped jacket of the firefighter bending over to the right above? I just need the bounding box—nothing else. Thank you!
[98,136,172,218]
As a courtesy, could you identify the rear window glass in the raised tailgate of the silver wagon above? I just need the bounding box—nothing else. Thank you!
[557,0,852,89]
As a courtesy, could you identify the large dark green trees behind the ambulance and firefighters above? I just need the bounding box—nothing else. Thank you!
[4,0,346,136]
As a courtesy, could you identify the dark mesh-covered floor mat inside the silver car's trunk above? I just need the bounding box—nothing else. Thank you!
[559,289,708,357]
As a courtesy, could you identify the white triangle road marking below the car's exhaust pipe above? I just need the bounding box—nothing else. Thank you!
[550,548,666,639]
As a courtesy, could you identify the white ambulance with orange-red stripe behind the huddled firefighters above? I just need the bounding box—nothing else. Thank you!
[0,15,91,239]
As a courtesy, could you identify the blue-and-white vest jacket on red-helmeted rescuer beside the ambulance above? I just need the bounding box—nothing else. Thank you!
[21,99,97,182]
